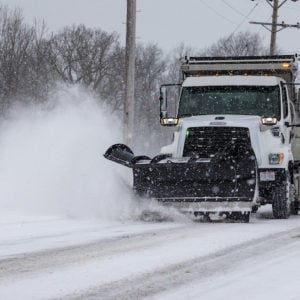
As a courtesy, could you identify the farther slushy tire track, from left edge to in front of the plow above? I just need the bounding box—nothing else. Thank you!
[0,225,189,279]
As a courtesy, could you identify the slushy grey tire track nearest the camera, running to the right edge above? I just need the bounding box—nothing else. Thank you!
[64,227,300,300]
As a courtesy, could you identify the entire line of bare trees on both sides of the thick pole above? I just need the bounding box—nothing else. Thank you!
[0,6,265,152]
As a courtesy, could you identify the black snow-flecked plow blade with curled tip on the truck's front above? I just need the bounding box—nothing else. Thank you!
[104,144,256,211]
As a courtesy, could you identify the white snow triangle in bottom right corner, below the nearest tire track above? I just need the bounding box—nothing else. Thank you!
[152,246,300,300]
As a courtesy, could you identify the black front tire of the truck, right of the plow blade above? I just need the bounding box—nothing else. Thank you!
[272,182,290,219]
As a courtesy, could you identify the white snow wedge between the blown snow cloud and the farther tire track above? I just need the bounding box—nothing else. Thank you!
[0,217,183,259]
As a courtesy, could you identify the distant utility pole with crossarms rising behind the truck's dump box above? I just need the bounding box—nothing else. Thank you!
[249,0,300,55]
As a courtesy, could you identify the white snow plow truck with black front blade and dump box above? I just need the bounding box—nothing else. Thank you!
[104,55,300,222]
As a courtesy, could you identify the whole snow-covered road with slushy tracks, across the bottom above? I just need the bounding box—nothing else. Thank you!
[0,212,300,299]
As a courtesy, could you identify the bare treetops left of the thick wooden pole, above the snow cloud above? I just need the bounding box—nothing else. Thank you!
[0,7,124,112]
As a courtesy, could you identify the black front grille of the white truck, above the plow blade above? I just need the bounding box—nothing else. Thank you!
[183,127,251,158]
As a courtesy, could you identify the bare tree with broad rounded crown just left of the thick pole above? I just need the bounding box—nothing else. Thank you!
[52,25,124,109]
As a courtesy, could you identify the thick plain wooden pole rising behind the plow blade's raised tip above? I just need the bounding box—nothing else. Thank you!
[124,0,136,147]
